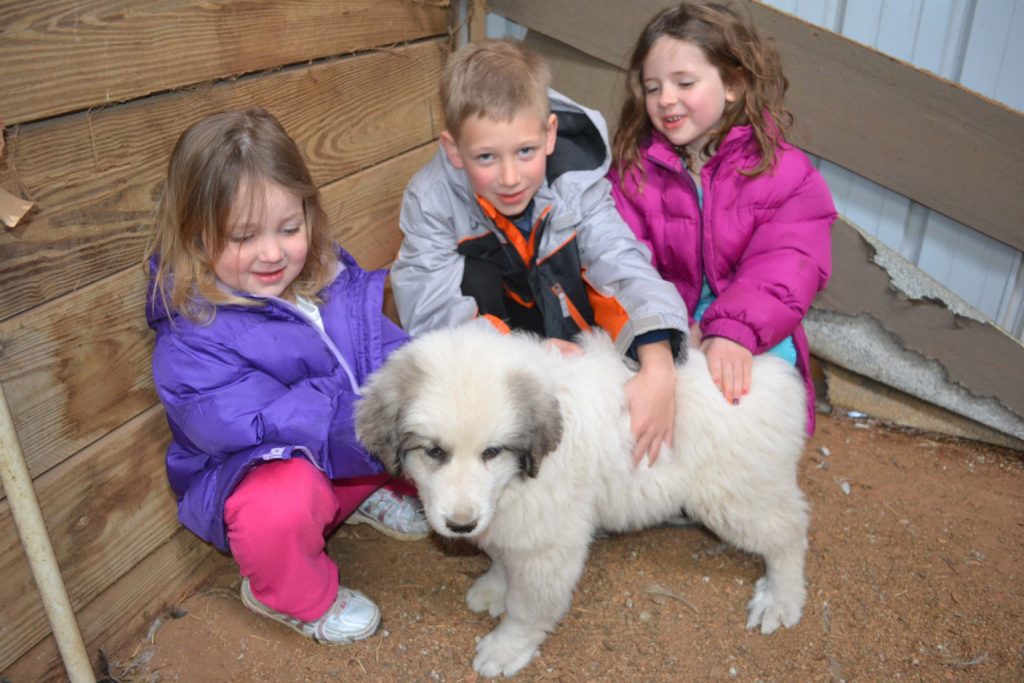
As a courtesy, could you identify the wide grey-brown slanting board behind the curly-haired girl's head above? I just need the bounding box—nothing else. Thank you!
[488,0,1024,249]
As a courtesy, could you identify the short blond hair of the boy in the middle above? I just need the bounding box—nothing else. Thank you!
[441,40,551,139]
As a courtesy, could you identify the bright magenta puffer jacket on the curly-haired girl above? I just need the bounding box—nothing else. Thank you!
[608,126,837,433]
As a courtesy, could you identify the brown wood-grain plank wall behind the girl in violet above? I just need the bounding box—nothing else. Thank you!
[0,0,451,681]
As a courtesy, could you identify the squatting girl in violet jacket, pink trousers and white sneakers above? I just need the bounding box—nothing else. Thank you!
[146,109,428,643]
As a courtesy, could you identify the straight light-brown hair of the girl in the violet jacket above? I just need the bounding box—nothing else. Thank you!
[146,108,337,323]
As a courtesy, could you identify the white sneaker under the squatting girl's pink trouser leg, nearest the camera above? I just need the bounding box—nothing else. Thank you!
[242,577,381,645]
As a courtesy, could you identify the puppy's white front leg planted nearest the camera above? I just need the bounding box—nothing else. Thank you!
[473,544,587,677]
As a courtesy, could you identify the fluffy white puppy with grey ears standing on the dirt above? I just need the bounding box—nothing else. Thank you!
[356,325,808,676]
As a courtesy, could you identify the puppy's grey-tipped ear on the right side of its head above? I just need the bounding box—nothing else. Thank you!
[509,370,562,477]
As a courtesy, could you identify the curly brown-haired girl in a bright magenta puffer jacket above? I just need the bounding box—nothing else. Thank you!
[609,4,836,432]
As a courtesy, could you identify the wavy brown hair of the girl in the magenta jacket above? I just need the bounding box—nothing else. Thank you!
[612,3,793,179]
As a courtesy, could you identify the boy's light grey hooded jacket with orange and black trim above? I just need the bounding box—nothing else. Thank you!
[391,90,688,353]
